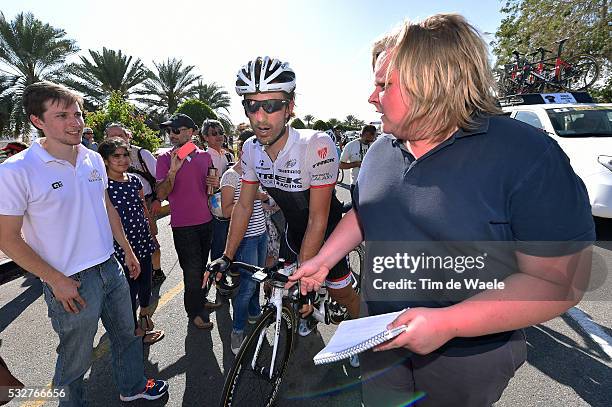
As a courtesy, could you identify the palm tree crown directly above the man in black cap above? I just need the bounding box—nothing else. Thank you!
[136,58,200,115]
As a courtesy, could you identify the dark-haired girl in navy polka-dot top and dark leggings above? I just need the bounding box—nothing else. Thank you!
[98,137,164,345]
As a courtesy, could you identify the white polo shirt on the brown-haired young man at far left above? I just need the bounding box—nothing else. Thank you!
[0,138,115,276]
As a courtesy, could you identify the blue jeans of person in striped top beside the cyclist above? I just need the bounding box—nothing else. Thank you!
[232,233,268,332]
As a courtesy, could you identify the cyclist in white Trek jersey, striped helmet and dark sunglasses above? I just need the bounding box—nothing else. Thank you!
[205,56,359,336]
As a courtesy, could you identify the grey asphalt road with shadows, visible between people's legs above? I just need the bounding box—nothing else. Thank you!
[0,174,612,407]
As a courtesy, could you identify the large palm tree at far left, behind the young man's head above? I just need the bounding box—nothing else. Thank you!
[0,12,79,135]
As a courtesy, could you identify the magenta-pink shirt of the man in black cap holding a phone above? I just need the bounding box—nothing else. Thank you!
[156,149,212,227]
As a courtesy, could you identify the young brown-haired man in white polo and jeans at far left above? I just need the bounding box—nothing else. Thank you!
[0,82,168,406]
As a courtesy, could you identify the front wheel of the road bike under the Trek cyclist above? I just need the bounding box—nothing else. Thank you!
[221,307,295,407]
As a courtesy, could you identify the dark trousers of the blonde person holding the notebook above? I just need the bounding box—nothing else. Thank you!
[359,330,527,407]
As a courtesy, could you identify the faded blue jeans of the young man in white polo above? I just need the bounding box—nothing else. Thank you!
[43,256,146,406]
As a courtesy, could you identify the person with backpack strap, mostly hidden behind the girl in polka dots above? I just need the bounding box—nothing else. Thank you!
[104,123,166,285]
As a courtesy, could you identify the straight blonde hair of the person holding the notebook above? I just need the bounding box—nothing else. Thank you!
[372,14,501,141]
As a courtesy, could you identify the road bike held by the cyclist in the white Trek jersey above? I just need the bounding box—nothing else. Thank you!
[220,245,363,407]
